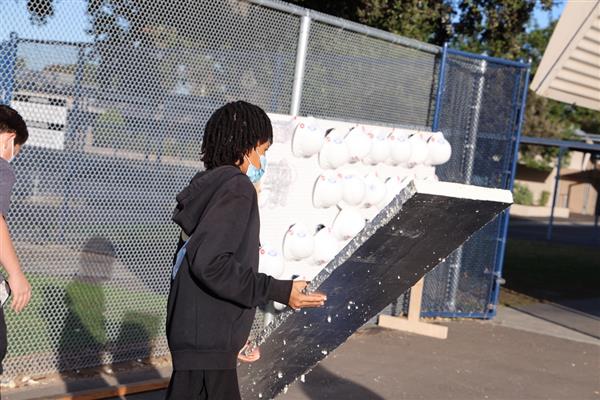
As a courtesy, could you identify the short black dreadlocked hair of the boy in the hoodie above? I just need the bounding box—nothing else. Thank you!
[201,101,273,169]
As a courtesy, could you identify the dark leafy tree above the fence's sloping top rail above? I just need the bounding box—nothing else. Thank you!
[290,0,552,51]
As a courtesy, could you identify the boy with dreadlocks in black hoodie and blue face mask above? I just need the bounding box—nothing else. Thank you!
[167,101,326,400]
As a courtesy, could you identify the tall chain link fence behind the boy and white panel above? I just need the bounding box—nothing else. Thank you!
[0,0,526,376]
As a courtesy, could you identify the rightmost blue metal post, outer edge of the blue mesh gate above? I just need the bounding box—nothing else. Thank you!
[486,64,531,318]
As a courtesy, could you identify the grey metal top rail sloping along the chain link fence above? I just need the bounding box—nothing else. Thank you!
[246,0,441,54]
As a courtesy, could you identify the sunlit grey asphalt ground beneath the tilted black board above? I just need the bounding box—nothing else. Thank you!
[110,311,600,400]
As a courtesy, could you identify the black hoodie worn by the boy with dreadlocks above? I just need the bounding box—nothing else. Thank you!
[167,166,292,370]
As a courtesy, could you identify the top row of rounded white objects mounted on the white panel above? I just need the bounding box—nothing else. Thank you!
[292,118,452,169]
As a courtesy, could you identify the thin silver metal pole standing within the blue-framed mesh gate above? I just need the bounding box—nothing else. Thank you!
[446,58,488,311]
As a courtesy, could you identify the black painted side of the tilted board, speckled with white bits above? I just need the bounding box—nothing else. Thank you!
[238,184,510,399]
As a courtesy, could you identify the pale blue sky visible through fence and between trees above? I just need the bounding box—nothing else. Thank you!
[0,0,566,69]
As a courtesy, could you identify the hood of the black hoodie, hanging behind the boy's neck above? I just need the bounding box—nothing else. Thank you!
[173,166,243,236]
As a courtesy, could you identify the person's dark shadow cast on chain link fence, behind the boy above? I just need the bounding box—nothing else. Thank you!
[44,237,160,392]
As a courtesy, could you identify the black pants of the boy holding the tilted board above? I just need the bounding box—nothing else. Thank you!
[166,369,241,400]
